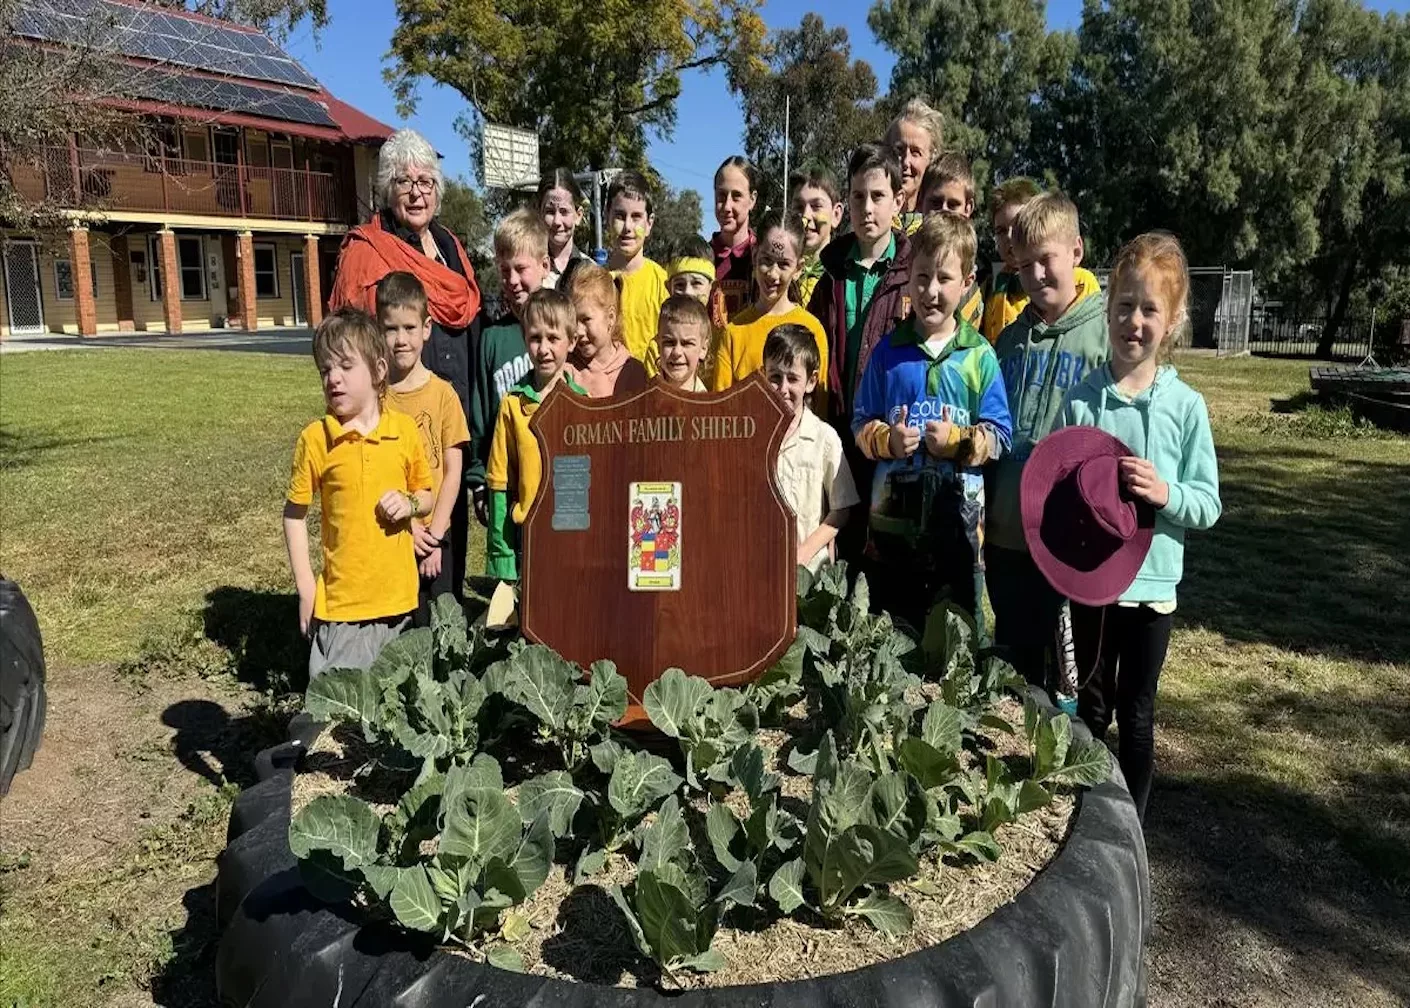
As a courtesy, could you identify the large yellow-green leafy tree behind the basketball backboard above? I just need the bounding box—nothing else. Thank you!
[386,0,764,179]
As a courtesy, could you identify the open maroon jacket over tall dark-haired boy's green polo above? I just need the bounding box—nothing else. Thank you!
[808,231,911,425]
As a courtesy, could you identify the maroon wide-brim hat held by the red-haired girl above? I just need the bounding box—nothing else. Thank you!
[1019,427,1155,606]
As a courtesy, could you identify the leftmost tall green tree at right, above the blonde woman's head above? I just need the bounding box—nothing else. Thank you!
[867,0,1073,198]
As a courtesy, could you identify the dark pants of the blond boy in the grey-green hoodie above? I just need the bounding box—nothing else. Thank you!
[984,544,1062,689]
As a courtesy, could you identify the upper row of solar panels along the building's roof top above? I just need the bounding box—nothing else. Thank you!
[14,0,319,87]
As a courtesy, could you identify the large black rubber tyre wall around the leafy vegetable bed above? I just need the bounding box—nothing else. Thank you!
[216,693,1151,1008]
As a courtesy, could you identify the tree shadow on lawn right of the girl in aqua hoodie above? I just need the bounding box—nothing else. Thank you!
[1177,448,1410,663]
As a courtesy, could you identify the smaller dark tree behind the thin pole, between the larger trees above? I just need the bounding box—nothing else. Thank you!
[737,14,885,217]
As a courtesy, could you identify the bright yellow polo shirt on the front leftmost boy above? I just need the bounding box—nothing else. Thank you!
[288,409,431,623]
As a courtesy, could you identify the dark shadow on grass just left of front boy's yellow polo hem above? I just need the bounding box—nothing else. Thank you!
[202,585,309,695]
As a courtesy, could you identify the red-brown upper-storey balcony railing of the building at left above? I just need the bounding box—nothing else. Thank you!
[16,147,357,224]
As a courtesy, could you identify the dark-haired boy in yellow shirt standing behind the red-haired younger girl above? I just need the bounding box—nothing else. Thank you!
[608,172,666,361]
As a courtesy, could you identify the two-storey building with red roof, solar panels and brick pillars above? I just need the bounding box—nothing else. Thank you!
[0,0,392,336]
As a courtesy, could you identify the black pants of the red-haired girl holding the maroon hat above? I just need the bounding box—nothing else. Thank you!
[1072,602,1175,822]
